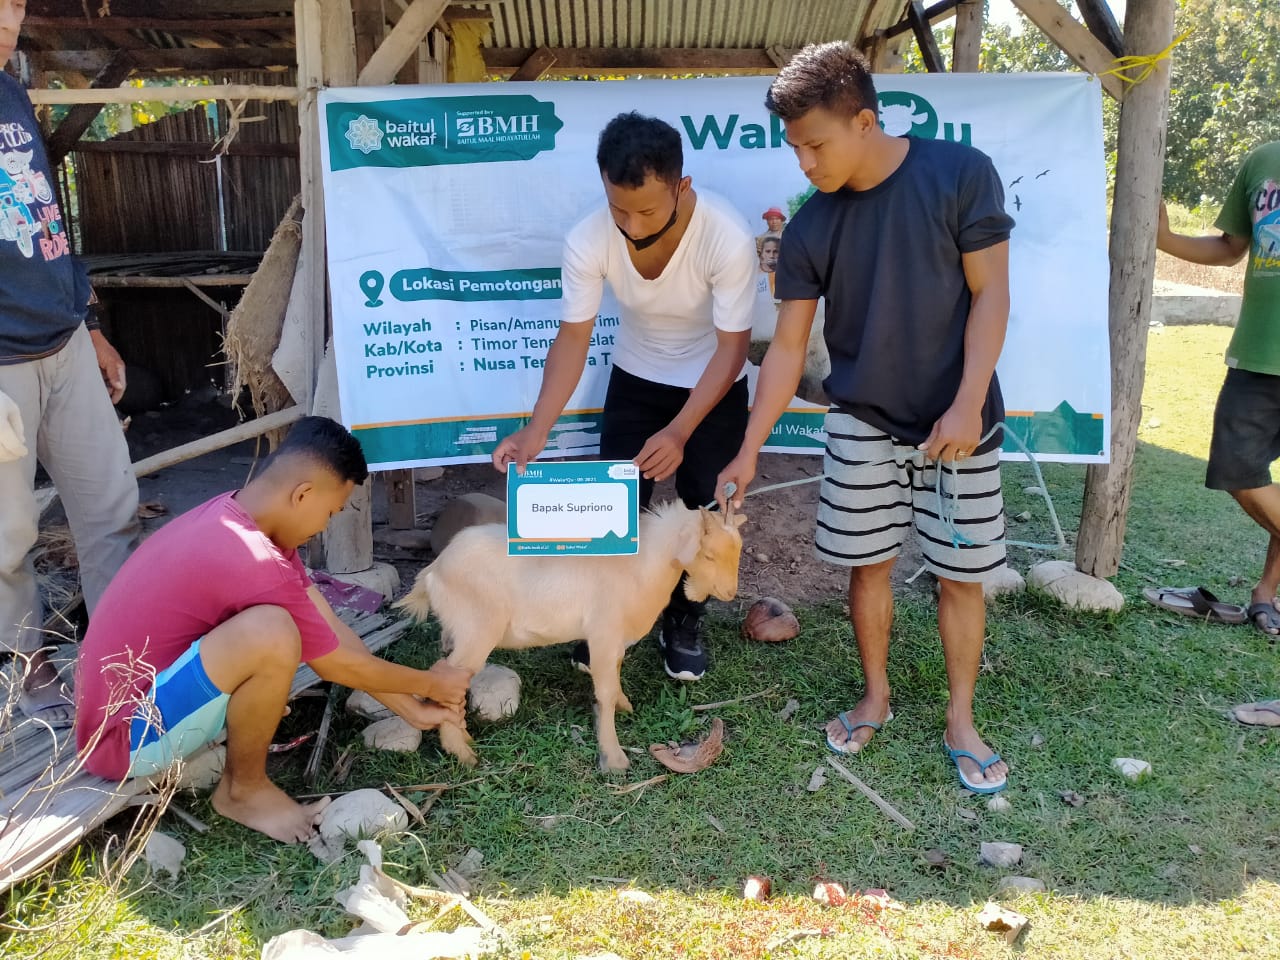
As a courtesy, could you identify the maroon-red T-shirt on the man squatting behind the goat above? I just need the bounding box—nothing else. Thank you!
[76,493,338,781]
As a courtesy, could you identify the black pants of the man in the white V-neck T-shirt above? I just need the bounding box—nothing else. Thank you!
[600,367,748,617]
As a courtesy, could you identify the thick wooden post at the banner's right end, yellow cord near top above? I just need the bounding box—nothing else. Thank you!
[1075,0,1174,577]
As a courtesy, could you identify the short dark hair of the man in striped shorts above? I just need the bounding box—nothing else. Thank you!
[764,40,879,120]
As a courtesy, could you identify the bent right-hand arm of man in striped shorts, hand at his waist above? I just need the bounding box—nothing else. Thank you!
[920,241,1009,460]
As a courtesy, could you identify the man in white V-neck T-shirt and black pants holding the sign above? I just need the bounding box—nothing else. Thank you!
[493,113,758,680]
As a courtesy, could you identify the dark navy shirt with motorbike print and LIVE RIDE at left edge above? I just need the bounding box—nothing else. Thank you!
[0,70,90,364]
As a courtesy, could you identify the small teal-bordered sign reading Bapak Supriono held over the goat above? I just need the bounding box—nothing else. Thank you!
[507,461,640,557]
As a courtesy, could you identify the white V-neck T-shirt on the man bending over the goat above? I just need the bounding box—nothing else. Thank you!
[561,189,759,388]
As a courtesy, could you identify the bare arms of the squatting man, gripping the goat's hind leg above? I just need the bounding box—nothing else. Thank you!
[307,586,471,722]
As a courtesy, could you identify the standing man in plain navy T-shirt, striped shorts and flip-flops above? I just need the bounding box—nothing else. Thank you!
[717,42,1014,794]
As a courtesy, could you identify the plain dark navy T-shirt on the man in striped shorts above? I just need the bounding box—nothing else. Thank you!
[774,138,1014,449]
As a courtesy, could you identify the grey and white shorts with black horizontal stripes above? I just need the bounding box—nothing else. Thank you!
[814,410,1005,582]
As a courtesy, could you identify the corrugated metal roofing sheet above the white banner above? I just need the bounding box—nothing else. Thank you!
[477,0,906,49]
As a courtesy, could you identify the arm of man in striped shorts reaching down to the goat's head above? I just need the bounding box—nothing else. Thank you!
[716,300,818,509]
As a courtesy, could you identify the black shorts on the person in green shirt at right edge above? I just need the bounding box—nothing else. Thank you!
[1204,369,1280,490]
